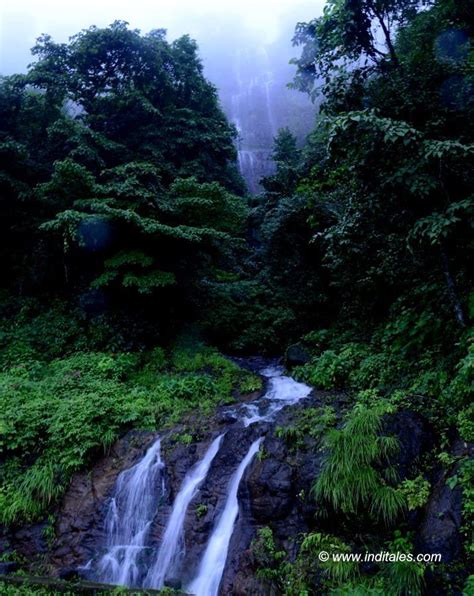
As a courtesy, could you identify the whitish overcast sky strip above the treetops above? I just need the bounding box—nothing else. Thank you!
[0,0,324,74]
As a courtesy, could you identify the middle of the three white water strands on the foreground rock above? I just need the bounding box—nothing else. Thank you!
[143,434,224,588]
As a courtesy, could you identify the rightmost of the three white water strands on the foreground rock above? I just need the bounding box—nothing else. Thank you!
[187,437,263,596]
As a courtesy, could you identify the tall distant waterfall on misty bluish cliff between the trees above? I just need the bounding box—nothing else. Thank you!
[206,44,316,194]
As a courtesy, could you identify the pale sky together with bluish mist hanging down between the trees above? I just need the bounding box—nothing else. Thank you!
[0,0,322,193]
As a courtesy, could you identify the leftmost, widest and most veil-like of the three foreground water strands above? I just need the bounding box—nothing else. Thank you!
[97,439,164,586]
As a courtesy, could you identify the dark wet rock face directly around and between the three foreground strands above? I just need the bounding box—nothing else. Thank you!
[44,388,315,594]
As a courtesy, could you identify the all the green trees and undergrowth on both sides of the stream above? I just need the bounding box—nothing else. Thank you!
[0,0,474,595]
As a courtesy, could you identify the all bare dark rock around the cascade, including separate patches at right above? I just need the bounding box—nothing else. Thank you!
[3,380,462,596]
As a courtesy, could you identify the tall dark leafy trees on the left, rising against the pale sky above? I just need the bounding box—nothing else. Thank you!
[0,22,246,336]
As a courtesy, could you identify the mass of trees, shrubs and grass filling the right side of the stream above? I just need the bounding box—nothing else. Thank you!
[246,0,474,594]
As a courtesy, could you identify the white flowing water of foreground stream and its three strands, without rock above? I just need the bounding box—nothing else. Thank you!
[90,366,311,596]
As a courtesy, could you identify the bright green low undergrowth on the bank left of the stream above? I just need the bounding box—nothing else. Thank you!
[0,305,259,524]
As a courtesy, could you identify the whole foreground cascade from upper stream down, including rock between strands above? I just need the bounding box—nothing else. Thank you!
[87,366,311,596]
